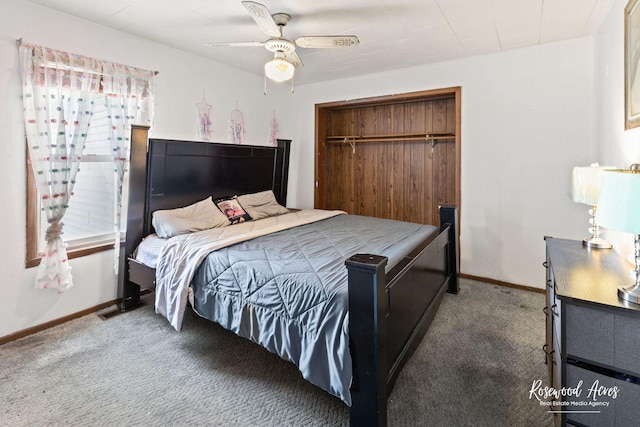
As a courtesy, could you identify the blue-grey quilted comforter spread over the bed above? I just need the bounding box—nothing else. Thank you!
[191,215,437,405]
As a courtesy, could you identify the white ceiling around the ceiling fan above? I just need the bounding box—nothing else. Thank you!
[29,0,613,84]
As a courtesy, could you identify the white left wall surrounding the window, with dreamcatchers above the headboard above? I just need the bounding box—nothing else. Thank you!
[0,0,295,337]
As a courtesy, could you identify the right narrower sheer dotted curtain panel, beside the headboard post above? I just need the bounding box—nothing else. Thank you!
[103,62,155,273]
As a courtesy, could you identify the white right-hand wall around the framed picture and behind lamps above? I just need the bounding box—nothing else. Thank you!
[594,0,640,257]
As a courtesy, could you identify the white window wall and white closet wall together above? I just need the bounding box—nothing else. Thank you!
[0,0,600,337]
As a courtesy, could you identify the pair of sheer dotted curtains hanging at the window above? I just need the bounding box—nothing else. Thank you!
[19,43,155,292]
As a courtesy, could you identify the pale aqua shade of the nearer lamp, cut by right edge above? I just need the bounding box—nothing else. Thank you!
[596,170,640,234]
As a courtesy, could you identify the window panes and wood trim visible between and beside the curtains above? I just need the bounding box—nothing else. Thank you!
[27,94,127,267]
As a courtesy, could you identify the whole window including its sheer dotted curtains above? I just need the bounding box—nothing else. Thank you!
[18,41,156,278]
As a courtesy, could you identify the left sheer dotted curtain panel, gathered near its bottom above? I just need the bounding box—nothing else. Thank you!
[19,44,101,292]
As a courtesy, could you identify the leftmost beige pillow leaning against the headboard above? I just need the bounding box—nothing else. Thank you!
[151,197,229,238]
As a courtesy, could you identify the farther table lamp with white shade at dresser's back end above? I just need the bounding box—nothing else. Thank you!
[570,163,615,249]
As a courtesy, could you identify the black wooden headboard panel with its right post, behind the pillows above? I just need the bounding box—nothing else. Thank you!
[143,139,290,235]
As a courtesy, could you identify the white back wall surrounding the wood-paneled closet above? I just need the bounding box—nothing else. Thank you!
[290,38,596,288]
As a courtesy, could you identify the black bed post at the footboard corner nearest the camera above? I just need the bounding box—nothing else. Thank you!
[345,254,388,426]
